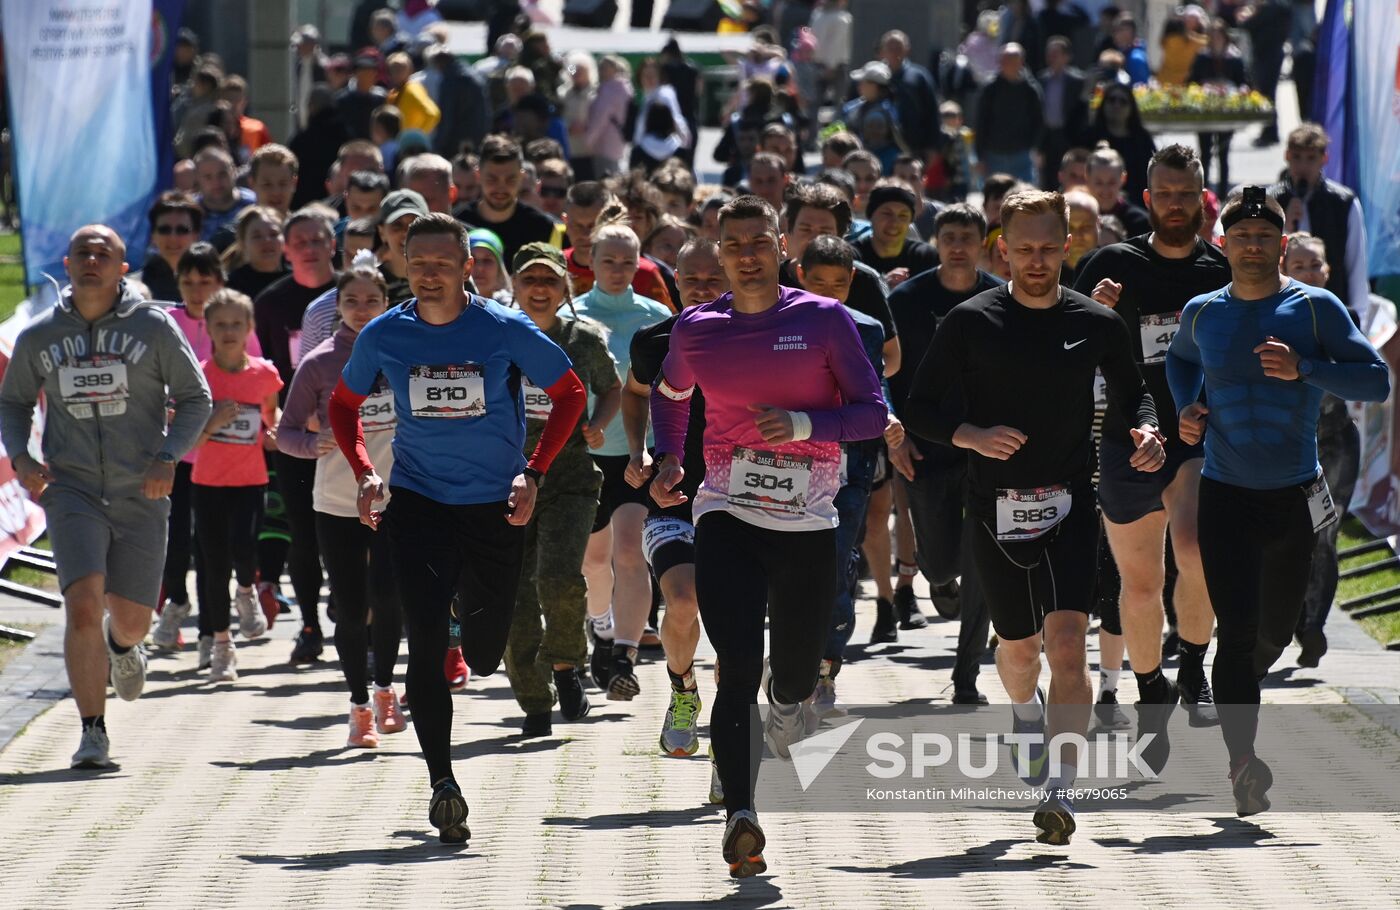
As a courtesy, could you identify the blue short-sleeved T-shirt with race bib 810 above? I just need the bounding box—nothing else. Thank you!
[340,295,571,505]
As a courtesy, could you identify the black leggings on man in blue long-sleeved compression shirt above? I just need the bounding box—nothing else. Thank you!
[1197,477,1317,760]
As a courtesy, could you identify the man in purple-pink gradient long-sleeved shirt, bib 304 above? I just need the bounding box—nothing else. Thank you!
[651,196,886,878]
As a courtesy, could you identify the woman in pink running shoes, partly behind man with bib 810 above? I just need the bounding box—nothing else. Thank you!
[277,251,407,749]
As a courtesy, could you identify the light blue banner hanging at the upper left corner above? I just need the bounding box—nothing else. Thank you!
[3,0,157,284]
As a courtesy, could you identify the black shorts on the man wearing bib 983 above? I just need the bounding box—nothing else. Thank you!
[963,486,1099,641]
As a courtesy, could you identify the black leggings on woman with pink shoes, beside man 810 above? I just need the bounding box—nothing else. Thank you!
[316,512,403,704]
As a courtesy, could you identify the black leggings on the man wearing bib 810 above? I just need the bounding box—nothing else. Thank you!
[383,487,525,783]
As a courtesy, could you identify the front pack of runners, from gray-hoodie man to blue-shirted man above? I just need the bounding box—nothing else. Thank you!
[0,137,1389,878]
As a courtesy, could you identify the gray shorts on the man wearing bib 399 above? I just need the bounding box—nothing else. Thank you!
[39,486,171,609]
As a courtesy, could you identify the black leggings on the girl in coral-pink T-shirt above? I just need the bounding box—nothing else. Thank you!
[192,483,267,634]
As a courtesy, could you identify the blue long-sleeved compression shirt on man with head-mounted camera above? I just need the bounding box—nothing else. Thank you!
[1166,280,1390,490]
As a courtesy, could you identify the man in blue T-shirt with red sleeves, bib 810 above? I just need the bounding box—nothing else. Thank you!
[328,213,585,843]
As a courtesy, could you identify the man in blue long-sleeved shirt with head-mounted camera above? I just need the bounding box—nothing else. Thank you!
[1166,186,1390,816]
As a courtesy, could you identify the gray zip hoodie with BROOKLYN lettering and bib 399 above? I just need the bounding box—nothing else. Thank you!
[0,281,211,500]
